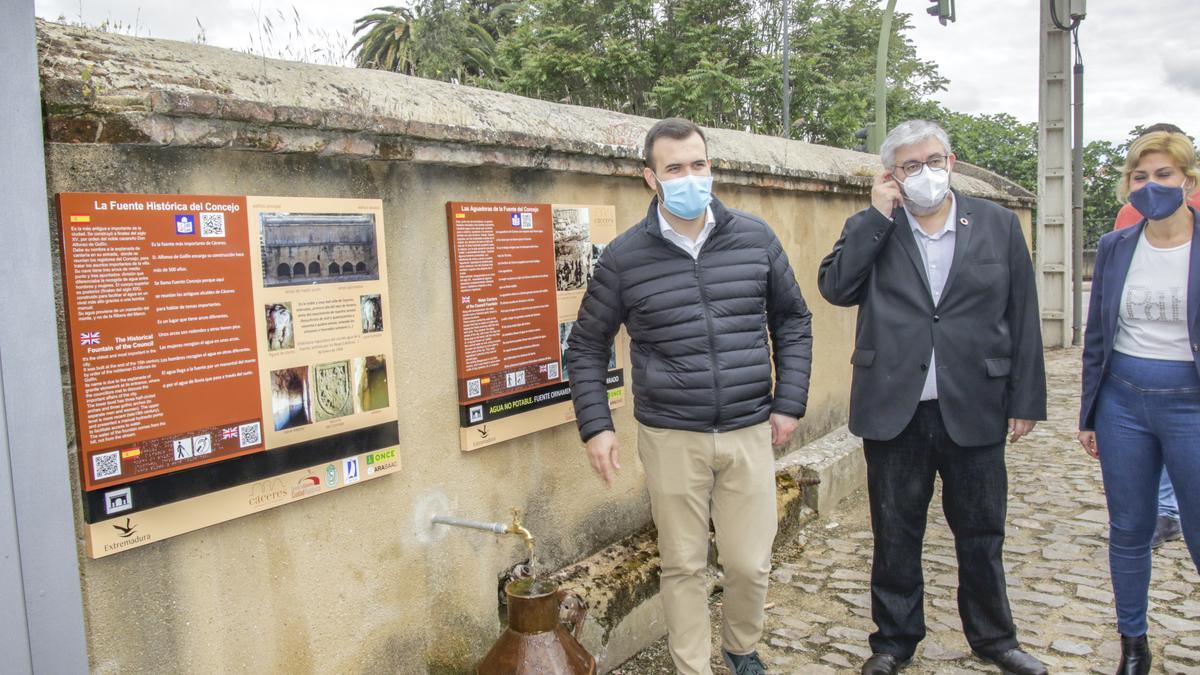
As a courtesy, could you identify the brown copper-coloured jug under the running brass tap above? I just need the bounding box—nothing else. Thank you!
[475,571,596,675]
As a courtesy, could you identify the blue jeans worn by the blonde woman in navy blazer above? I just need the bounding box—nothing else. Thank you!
[1096,352,1200,637]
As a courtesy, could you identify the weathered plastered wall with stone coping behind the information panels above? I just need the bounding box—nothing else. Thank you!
[38,23,1032,673]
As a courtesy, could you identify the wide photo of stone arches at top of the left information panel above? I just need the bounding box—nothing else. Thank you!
[259,214,379,287]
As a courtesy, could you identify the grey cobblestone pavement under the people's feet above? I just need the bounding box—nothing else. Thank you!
[614,350,1200,675]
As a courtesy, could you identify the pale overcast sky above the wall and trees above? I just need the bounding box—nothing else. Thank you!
[35,0,1200,142]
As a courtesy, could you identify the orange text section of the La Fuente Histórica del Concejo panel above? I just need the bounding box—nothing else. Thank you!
[60,195,263,490]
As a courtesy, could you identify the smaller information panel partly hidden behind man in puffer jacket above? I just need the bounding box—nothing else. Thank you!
[446,202,624,450]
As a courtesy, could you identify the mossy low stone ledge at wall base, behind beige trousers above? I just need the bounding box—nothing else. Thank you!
[540,428,866,673]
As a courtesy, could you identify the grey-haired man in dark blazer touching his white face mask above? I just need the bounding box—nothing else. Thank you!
[818,120,1046,675]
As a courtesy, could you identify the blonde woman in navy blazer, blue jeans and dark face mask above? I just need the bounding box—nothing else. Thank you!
[1079,131,1200,675]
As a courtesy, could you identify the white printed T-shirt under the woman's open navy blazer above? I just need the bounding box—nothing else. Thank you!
[1112,229,1192,362]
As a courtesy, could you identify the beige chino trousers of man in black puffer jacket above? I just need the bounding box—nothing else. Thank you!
[637,422,779,675]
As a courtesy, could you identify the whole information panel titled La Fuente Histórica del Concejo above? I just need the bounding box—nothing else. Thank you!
[58,193,400,557]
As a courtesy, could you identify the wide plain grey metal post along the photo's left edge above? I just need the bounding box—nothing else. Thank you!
[0,0,88,674]
